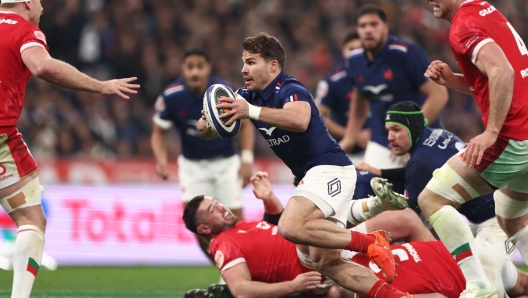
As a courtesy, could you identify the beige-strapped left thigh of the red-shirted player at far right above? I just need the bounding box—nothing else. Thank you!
[418,154,493,217]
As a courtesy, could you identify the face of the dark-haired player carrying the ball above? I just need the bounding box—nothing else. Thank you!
[241,51,274,93]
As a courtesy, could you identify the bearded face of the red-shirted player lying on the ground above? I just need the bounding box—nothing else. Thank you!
[196,197,238,235]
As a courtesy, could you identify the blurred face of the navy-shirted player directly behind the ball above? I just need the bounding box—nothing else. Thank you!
[182,55,211,93]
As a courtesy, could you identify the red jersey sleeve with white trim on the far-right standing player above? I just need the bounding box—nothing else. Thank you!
[450,22,494,64]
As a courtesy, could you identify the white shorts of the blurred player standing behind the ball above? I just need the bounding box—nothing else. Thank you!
[178,154,243,209]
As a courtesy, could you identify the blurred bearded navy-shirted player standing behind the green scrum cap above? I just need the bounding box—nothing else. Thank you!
[340,5,448,169]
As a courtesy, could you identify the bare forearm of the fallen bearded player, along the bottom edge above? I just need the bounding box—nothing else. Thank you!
[222,263,321,298]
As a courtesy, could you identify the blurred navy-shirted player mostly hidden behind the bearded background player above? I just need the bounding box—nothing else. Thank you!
[315,31,370,163]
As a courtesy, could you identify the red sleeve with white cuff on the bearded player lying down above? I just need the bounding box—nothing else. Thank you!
[210,237,246,272]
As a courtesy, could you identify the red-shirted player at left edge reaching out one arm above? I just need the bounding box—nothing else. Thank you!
[0,0,139,297]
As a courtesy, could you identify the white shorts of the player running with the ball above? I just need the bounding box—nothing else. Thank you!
[293,165,357,227]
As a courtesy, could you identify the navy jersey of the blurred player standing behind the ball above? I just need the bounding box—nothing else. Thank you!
[154,77,237,159]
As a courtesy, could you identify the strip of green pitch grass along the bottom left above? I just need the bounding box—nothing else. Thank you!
[0,266,528,298]
